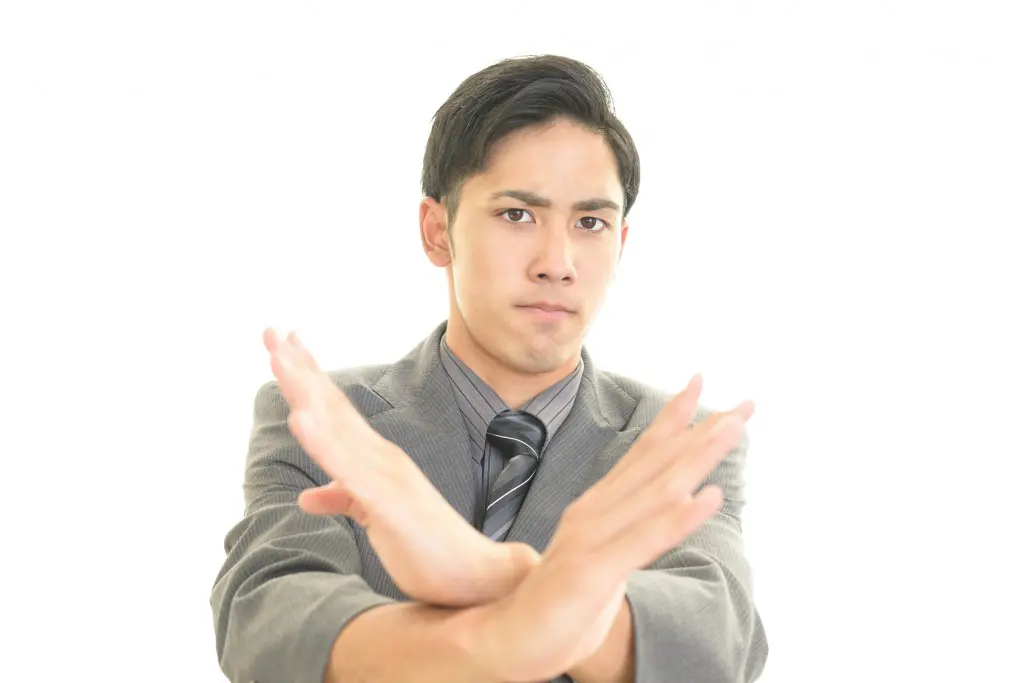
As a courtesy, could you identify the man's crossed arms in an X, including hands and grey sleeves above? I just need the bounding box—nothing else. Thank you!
[211,332,767,683]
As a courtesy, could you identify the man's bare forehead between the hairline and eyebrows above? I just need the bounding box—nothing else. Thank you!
[463,120,623,205]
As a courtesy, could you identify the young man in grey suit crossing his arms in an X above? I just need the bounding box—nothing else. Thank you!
[211,56,768,683]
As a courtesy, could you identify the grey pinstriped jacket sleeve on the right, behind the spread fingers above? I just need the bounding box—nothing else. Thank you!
[626,412,768,683]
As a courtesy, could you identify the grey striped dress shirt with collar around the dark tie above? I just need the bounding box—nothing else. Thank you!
[440,334,583,528]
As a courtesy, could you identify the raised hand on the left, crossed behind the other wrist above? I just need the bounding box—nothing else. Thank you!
[264,331,536,606]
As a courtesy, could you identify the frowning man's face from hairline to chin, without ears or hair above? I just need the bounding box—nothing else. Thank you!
[447,120,629,373]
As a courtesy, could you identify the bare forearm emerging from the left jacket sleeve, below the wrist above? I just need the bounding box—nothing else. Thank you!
[324,602,500,683]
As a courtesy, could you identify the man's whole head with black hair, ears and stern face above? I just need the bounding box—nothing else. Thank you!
[420,56,640,379]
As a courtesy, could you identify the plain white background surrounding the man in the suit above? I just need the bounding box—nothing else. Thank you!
[0,0,1024,683]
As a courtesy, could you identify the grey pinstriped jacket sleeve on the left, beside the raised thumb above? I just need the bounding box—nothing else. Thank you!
[210,382,393,683]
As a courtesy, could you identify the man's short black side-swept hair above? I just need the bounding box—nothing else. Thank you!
[421,54,640,226]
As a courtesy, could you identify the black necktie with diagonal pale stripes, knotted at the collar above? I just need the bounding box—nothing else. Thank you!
[481,410,547,541]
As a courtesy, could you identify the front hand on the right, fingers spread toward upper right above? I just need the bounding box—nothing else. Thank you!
[460,377,754,681]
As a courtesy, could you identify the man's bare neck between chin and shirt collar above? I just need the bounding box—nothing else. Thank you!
[445,315,580,410]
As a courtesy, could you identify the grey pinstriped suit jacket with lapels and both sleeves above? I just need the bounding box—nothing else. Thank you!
[210,322,768,683]
